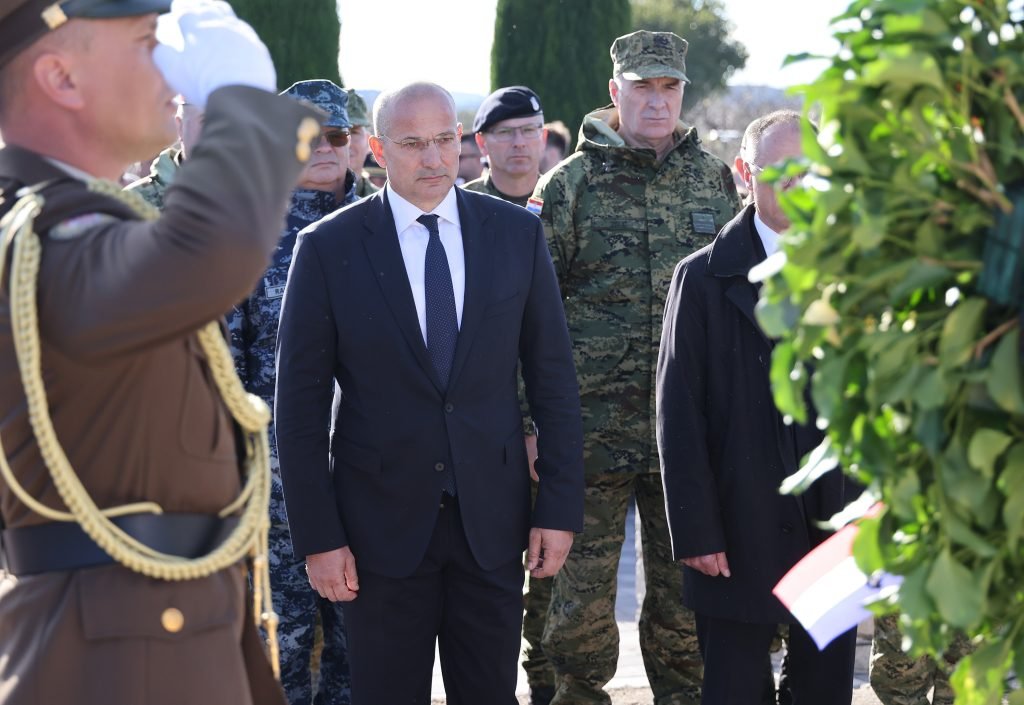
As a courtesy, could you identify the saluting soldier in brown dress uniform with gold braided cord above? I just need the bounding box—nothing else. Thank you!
[0,0,321,705]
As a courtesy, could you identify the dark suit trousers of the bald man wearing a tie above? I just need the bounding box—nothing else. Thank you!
[344,496,523,705]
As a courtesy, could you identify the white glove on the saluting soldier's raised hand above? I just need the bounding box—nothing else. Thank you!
[153,0,278,109]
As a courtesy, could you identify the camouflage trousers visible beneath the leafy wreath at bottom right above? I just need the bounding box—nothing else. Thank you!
[868,615,970,705]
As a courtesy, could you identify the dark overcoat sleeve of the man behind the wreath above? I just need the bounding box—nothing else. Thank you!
[656,256,727,559]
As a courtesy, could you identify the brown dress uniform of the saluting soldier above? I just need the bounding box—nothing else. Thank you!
[0,68,318,705]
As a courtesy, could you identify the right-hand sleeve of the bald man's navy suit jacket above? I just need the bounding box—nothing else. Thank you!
[519,221,584,531]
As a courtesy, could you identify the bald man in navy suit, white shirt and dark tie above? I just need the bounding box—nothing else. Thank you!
[275,84,583,705]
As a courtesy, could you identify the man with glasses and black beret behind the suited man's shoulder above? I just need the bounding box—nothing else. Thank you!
[463,86,548,207]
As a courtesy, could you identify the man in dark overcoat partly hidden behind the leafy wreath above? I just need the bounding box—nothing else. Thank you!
[657,111,856,705]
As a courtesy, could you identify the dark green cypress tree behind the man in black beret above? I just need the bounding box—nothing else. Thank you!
[490,0,630,145]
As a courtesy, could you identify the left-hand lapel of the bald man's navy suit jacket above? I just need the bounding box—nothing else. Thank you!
[362,191,442,391]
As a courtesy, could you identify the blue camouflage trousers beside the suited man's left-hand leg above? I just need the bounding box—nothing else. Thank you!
[270,525,352,705]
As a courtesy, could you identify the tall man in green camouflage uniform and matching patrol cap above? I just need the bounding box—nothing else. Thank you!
[527,31,739,705]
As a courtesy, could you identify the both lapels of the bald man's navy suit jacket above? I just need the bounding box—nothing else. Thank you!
[364,189,494,397]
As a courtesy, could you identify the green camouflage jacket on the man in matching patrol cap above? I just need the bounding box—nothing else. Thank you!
[528,107,739,473]
